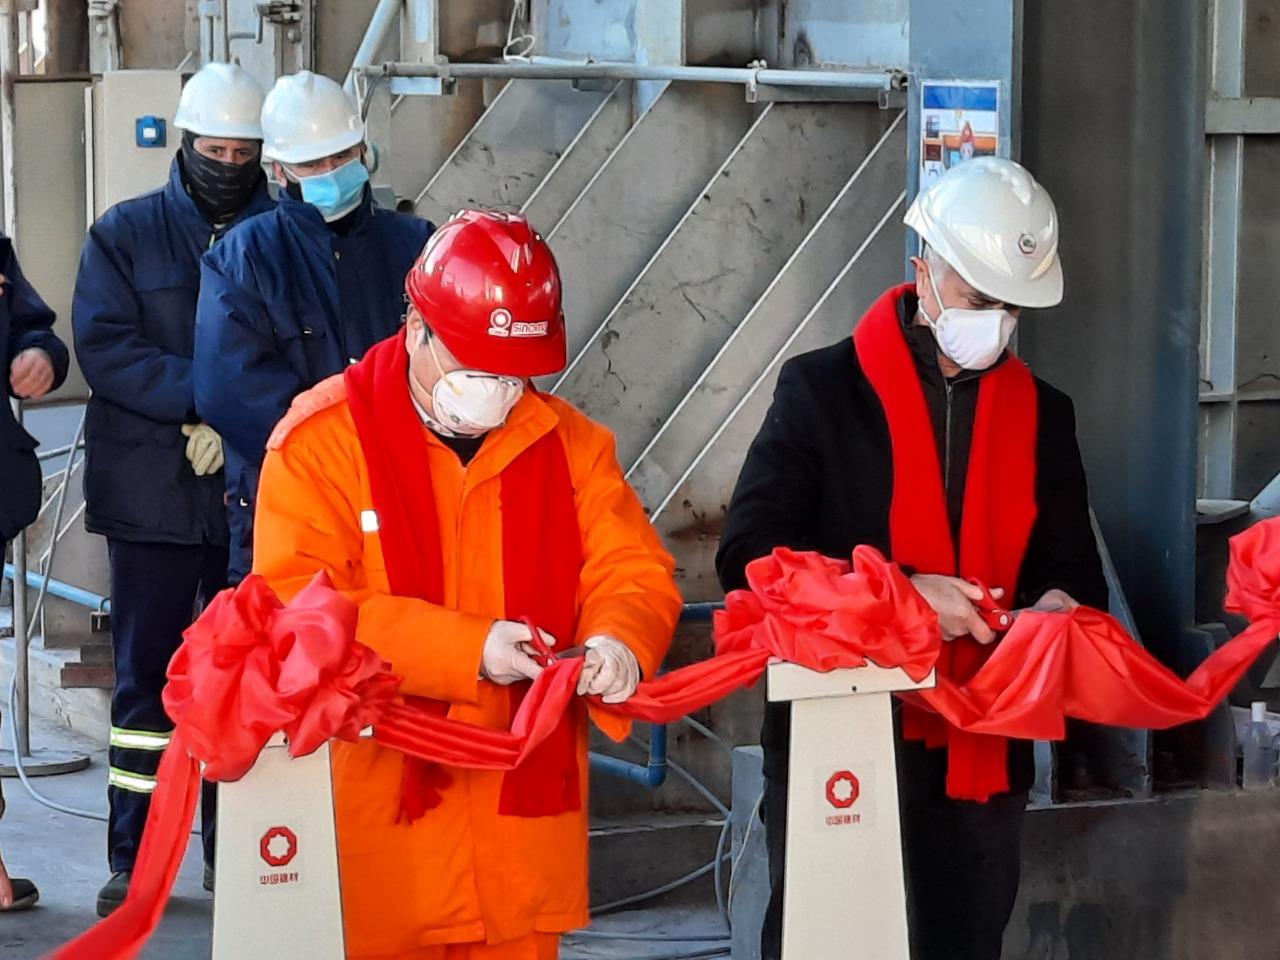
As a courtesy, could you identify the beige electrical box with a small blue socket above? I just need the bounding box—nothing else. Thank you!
[84,70,183,223]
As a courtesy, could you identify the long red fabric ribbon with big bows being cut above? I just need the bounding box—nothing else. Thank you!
[52,527,1280,960]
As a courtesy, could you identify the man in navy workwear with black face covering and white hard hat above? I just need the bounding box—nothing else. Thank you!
[72,63,271,916]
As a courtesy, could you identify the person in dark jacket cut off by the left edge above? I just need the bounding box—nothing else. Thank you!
[0,229,68,911]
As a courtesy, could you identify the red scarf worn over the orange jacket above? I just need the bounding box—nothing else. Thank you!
[346,334,582,820]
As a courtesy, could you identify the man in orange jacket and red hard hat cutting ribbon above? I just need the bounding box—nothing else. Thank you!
[255,211,681,960]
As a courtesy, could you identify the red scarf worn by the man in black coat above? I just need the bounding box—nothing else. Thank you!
[854,284,1037,801]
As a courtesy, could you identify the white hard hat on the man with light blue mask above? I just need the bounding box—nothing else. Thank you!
[262,70,365,164]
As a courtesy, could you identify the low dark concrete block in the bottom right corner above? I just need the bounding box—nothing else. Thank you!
[1004,791,1280,960]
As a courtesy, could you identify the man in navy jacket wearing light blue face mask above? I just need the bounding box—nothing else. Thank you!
[196,70,431,582]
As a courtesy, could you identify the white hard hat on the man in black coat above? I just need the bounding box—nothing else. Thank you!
[906,156,1062,307]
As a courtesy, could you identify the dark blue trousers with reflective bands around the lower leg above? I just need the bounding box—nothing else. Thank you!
[106,539,227,873]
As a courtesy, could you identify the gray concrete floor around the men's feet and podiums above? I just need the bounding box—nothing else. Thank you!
[0,719,727,960]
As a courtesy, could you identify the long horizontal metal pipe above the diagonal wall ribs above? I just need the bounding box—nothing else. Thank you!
[352,59,906,93]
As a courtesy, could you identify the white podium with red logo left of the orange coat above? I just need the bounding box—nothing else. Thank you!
[212,735,347,960]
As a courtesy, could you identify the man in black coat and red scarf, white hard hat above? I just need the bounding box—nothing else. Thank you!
[717,157,1107,960]
